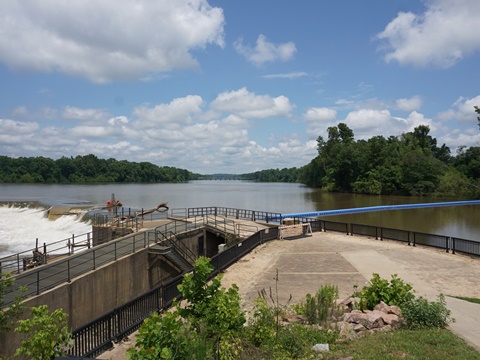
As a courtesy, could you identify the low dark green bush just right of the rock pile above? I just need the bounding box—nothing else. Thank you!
[401,294,453,329]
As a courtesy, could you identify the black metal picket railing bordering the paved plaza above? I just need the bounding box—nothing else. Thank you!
[64,208,480,356]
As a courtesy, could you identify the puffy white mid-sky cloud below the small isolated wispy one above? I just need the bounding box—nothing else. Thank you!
[210,88,293,119]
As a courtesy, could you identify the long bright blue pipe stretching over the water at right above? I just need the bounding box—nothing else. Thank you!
[272,200,480,220]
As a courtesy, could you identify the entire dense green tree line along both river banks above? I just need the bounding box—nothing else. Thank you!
[0,123,480,199]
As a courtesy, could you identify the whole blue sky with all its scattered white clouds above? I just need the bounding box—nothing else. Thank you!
[0,0,480,174]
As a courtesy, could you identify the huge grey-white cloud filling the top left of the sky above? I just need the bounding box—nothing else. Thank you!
[0,0,225,83]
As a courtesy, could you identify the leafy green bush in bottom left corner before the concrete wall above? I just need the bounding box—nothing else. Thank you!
[15,305,71,360]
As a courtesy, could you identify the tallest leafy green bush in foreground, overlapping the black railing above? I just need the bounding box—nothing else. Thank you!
[128,257,246,359]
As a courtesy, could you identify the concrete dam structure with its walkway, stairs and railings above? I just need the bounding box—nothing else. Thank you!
[0,202,480,356]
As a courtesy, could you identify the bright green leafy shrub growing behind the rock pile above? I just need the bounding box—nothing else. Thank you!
[354,274,415,310]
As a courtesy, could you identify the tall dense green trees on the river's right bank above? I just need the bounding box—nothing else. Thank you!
[243,123,480,198]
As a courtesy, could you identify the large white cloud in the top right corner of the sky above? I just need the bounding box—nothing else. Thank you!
[377,0,480,68]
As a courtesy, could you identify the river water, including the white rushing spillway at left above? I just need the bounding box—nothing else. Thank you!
[0,180,480,256]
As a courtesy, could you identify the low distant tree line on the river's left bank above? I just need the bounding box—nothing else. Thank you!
[0,154,200,183]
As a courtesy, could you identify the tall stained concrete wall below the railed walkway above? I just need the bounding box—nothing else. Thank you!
[0,229,225,357]
